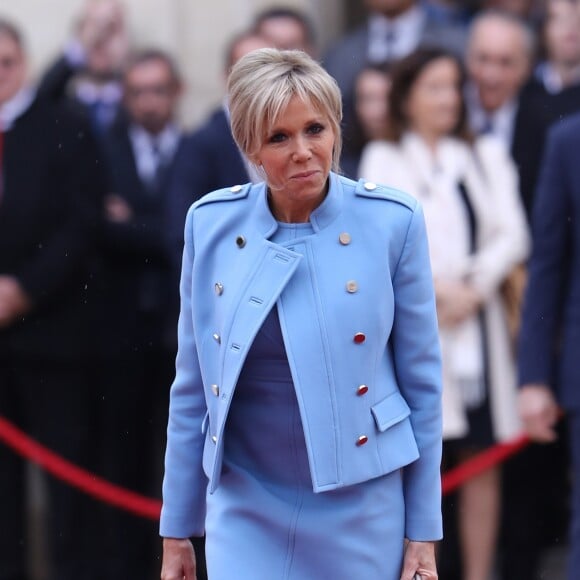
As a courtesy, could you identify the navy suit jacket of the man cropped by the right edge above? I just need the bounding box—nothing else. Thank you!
[519,115,580,409]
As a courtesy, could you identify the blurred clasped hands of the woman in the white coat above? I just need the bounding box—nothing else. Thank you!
[435,280,482,327]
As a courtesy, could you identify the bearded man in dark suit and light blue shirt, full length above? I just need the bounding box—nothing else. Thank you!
[90,50,198,580]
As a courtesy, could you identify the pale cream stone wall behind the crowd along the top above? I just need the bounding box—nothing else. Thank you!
[0,0,343,126]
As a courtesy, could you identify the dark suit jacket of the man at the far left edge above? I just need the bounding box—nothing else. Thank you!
[0,98,103,360]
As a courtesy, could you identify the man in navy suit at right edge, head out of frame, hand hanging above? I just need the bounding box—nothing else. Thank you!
[519,115,580,580]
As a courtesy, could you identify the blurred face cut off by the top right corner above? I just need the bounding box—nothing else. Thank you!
[544,0,580,65]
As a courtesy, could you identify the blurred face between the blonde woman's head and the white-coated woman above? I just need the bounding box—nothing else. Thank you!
[355,70,391,139]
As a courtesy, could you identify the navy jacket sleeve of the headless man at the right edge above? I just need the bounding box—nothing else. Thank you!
[518,127,574,385]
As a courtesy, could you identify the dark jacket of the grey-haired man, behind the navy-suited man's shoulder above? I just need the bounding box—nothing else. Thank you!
[512,80,580,215]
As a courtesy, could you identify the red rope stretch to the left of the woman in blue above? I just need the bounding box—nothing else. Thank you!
[0,417,161,520]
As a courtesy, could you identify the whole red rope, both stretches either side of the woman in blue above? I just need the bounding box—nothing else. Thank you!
[0,416,530,520]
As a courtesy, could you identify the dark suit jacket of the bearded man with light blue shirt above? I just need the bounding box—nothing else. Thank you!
[95,120,183,354]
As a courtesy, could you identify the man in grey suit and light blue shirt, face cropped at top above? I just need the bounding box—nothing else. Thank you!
[324,0,466,122]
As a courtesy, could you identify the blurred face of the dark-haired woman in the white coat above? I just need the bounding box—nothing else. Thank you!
[406,58,462,137]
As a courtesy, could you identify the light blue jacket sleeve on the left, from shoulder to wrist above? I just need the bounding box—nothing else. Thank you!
[160,210,207,538]
